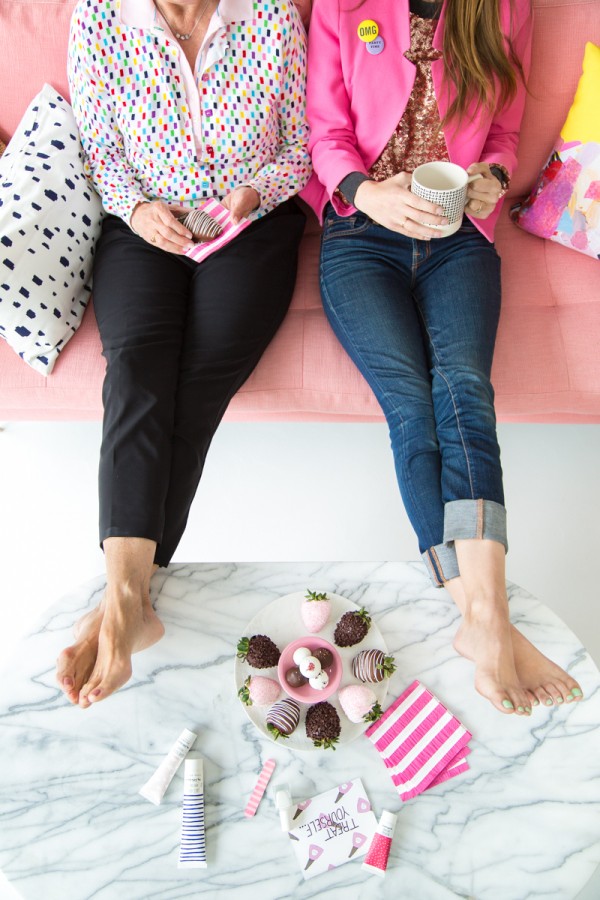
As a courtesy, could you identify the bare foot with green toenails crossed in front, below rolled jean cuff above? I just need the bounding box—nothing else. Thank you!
[454,604,532,716]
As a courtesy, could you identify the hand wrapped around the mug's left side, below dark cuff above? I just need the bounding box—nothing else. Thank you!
[354,172,448,240]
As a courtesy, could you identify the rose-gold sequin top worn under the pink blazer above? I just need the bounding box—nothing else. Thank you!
[369,12,450,181]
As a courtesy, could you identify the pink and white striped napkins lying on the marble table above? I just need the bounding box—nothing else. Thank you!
[365,681,472,800]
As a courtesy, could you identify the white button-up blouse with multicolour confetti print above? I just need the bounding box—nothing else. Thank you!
[69,0,310,222]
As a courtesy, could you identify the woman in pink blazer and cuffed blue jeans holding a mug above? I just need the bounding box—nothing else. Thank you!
[303,0,582,715]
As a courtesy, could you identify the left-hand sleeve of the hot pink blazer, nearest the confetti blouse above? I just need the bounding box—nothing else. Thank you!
[307,0,367,214]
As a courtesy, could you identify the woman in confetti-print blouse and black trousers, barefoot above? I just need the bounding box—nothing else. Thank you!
[57,0,310,708]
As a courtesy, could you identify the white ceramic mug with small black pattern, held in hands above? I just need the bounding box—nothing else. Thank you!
[410,160,482,237]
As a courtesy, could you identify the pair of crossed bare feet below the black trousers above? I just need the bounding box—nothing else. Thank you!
[56,595,164,709]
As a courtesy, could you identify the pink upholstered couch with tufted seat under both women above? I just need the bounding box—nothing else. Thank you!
[0,0,600,422]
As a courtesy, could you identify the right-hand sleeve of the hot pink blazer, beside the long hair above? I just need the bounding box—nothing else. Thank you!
[480,0,533,174]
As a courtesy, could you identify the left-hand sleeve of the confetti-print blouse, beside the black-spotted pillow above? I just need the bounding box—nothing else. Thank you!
[67,4,147,224]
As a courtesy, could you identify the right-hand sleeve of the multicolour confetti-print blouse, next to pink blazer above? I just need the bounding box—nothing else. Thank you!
[246,4,312,211]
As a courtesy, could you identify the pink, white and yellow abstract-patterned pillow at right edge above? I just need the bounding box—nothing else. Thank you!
[510,43,600,259]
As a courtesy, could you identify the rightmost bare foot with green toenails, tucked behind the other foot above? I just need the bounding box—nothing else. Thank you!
[511,625,583,706]
